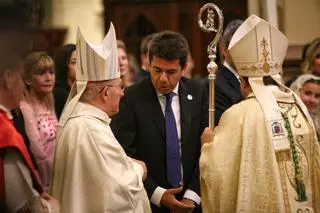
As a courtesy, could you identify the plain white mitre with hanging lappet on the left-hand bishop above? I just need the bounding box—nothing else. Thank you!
[59,23,120,127]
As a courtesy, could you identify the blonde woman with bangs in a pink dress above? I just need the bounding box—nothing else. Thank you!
[20,52,57,191]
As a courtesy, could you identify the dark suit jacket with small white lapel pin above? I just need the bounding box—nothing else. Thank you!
[111,78,208,213]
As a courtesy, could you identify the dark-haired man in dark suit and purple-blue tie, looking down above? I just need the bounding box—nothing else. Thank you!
[111,31,208,213]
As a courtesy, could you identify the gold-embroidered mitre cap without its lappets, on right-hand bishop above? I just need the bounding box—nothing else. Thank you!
[228,15,288,77]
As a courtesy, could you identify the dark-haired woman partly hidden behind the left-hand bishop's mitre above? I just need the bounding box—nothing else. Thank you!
[54,44,76,118]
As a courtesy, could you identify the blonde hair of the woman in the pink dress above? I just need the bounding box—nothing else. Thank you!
[24,52,55,110]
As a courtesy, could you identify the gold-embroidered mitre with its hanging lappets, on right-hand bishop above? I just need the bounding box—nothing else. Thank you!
[228,15,290,151]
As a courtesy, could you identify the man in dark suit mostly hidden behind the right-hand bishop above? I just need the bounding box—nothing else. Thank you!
[206,20,243,125]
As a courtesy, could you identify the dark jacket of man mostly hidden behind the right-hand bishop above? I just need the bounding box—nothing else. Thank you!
[206,65,242,126]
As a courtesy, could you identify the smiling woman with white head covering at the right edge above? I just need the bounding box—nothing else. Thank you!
[290,74,320,138]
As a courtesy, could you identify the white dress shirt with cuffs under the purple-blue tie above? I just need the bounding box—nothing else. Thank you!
[150,82,201,206]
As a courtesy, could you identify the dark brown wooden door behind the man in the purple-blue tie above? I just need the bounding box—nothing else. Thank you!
[104,0,247,76]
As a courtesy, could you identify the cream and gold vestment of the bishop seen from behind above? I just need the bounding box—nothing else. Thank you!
[200,85,320,213]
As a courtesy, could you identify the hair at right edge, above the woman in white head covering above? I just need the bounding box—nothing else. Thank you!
[301,38,320,74]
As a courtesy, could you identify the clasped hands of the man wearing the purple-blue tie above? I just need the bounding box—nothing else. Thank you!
[160,188,195,213]
